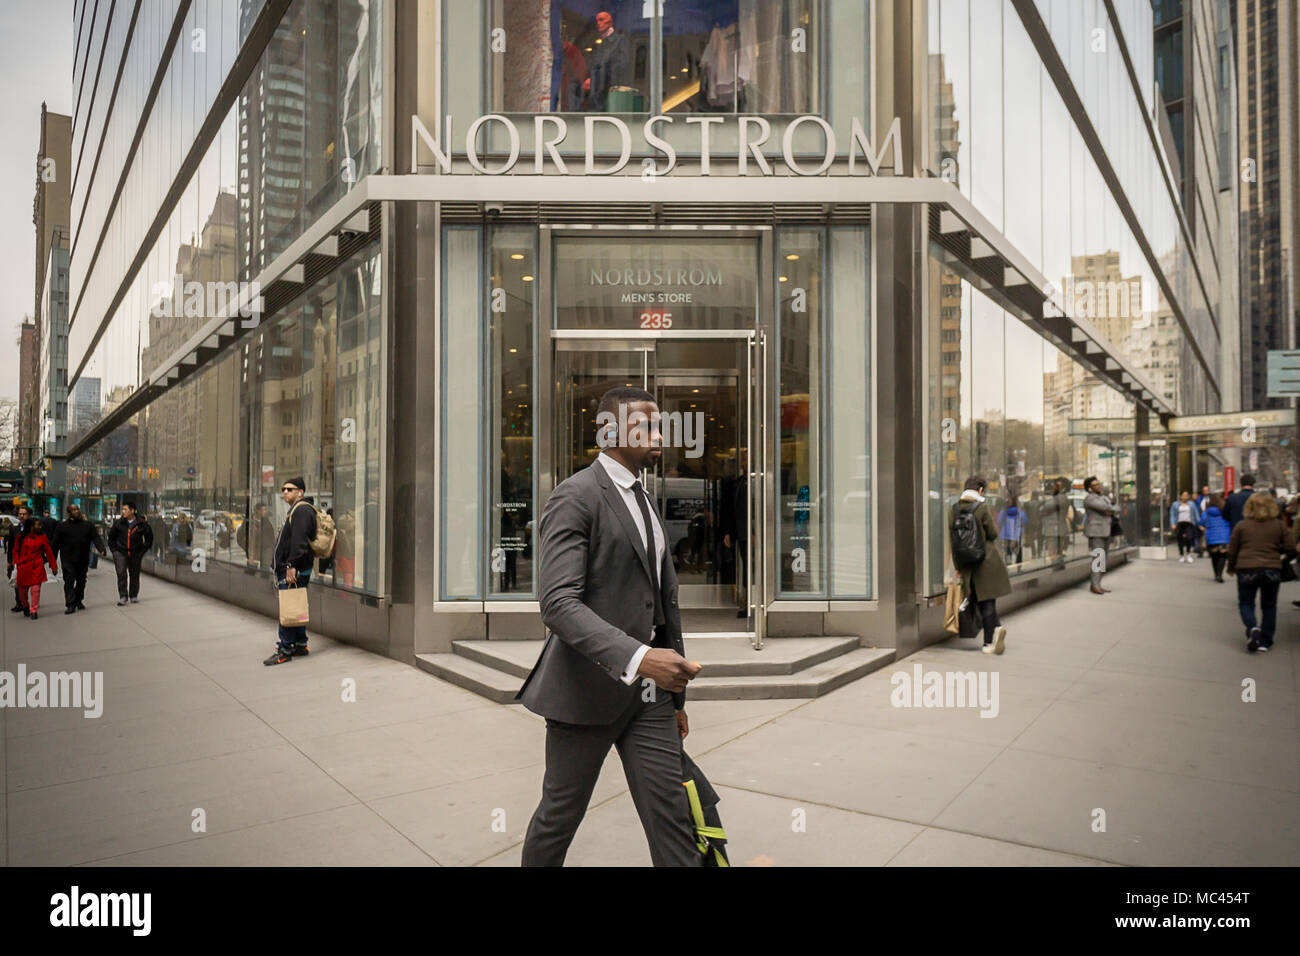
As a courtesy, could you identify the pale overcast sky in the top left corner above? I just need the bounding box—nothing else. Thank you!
[0,0,73,398]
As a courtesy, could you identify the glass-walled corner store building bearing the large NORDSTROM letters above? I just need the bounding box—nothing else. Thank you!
[69,0,1236,659]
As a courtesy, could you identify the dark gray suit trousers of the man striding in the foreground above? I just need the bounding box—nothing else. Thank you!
[523,683,703,866]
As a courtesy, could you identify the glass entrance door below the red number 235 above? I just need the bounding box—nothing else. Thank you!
[551,330,766,645]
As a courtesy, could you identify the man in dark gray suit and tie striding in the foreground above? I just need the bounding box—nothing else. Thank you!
[519,388,702,866]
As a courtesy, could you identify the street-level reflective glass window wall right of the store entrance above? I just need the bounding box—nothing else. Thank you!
[926,245,1144,594]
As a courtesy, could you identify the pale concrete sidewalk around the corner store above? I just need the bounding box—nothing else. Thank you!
[0,562,1300,866]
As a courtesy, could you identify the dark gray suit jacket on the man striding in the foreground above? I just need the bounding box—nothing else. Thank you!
[517,462,686,724]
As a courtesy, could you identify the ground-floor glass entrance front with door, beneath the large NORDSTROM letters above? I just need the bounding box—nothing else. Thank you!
[439,225,872,604]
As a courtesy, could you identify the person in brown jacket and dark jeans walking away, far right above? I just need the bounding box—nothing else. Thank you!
[1227,492,1295,654]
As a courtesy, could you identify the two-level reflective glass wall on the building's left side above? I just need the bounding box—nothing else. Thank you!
[68,0,386,594]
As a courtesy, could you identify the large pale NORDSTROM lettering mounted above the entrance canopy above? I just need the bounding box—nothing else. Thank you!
[411,113,904,176]
